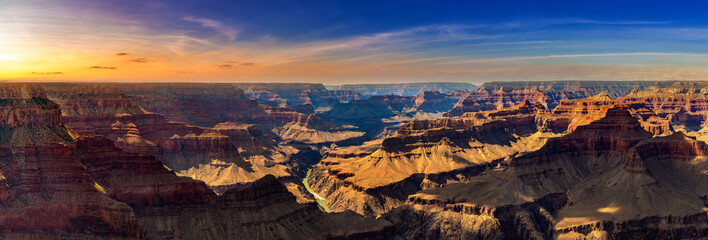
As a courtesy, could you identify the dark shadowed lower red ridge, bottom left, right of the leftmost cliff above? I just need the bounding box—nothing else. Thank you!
[77,136,390,239]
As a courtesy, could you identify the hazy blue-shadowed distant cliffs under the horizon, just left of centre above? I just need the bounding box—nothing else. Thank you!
[234,83,362,108]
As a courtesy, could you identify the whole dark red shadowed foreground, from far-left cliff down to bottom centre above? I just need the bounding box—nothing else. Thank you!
[0,84,391,239]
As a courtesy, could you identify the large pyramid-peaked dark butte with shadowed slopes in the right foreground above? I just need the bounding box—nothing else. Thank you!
[384,107,708,239]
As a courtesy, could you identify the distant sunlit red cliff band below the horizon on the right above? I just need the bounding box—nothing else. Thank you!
[447,81,668,116]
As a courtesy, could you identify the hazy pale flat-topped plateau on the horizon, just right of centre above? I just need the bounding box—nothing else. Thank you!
[339,82,477,96]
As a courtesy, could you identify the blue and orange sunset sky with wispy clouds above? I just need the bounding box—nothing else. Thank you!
[0,0,708,84]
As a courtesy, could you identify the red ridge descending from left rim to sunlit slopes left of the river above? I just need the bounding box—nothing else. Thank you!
[43,84,309,201]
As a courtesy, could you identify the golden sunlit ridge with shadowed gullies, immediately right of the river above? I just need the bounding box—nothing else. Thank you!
[308,102,554,216]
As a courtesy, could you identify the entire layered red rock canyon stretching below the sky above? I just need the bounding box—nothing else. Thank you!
[0,81,708,239]
